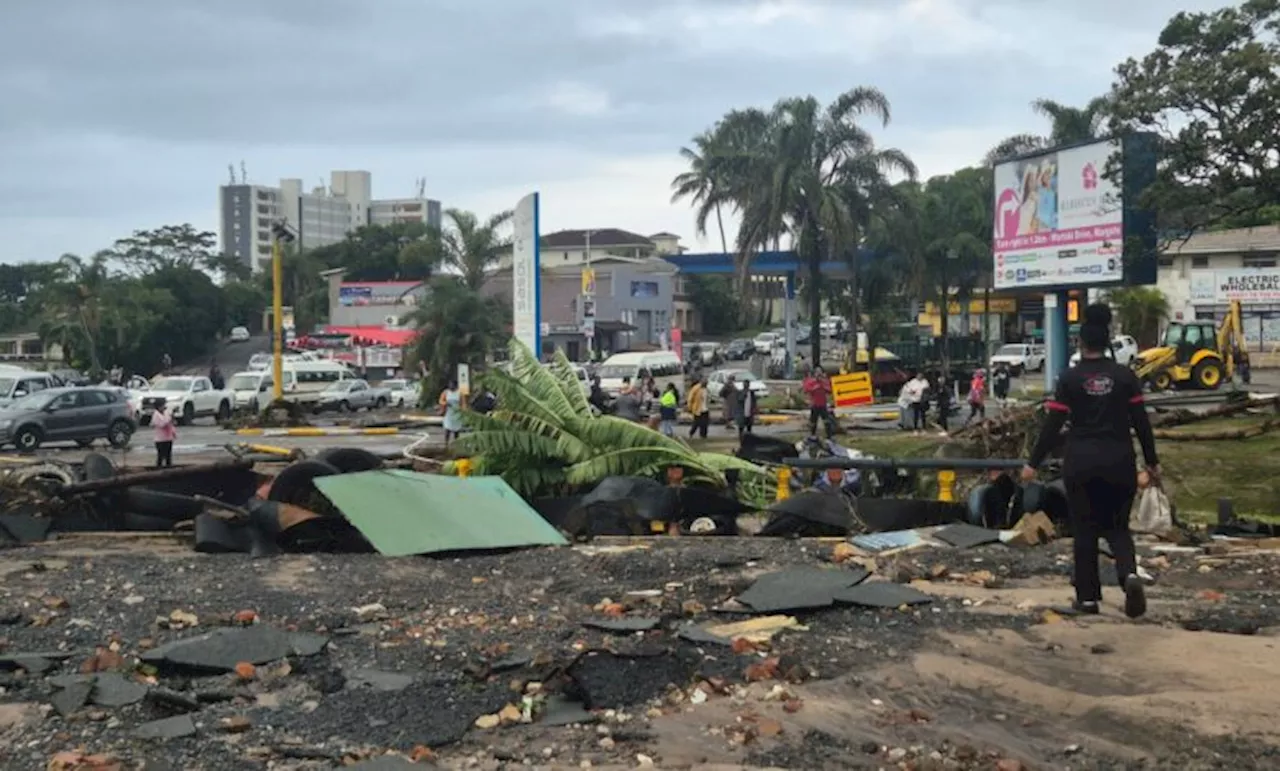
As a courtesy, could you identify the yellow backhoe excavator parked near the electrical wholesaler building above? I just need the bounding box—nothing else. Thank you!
[1134,301,1247,391]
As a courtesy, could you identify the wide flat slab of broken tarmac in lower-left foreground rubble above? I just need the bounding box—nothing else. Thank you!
[140,624,329,672]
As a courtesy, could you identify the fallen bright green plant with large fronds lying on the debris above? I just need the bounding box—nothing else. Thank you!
[445,341,774,507]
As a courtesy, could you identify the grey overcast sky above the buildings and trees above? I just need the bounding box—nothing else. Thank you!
[0,0,1226,261]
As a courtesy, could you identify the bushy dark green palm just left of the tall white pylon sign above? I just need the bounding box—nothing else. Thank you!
[408,275,511,403]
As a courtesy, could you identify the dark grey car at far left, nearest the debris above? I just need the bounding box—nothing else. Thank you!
[0,387,137,452]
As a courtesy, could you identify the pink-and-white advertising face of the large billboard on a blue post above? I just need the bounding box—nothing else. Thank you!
[993,140,1124,289]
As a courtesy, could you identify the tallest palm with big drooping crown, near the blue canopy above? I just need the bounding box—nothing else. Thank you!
[739,87,915,361]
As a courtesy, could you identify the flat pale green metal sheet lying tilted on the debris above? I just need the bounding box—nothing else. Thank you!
[315,469,568,557]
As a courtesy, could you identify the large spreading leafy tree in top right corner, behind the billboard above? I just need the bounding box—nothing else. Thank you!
[1108,0,1280,232]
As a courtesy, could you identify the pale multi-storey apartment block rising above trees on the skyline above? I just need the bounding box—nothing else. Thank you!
[219,170,440,272]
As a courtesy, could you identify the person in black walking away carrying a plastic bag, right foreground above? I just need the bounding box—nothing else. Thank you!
[1021,304,1160,619]
